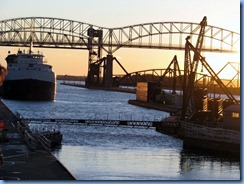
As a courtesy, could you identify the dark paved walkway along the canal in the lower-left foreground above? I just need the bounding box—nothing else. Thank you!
[0,101,75,180]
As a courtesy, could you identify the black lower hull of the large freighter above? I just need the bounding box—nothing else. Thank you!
[1,79,56,101]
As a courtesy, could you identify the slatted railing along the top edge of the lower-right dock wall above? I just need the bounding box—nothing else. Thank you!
[181,122,240,144]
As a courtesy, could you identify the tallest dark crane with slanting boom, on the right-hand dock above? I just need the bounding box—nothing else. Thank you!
[181,17,240,120]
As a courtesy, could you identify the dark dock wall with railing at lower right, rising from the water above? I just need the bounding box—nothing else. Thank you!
[181,122,241,157]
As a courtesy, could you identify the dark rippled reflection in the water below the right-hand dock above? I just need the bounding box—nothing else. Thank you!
[179,149,240,180]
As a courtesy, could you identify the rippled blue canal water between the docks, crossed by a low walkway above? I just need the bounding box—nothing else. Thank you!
[3,81,240,181]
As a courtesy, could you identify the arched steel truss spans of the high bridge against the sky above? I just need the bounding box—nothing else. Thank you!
[0,17,240,54]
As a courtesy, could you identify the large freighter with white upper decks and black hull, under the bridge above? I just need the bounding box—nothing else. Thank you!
[1,44,56,101]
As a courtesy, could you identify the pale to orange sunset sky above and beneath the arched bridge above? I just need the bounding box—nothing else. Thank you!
[0,0,240,78]
